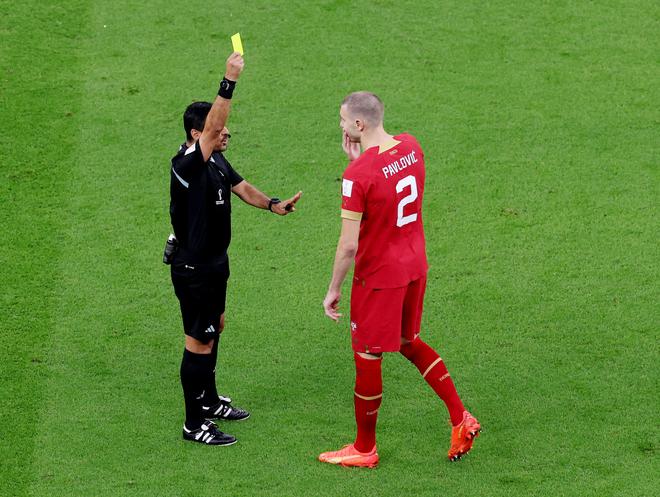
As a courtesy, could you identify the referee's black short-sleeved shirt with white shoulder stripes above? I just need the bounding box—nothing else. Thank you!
[170,142,243,263]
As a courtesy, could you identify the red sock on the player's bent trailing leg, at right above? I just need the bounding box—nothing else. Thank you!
[401,338,465,426]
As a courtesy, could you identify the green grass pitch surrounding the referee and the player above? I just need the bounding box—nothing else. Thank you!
[0,0,660,497]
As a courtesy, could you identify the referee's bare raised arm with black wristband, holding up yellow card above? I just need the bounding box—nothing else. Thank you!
[199,52,245,161]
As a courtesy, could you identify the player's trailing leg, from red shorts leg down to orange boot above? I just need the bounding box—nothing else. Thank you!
[400,278,481,460]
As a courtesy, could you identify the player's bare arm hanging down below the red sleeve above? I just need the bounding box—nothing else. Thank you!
[323,217,360,321]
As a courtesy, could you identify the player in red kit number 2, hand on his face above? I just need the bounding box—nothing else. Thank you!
[319,92,481,467]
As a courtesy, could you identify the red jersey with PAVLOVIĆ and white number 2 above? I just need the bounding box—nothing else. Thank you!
[341,133,428,288]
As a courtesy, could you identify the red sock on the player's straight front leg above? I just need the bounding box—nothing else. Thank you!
[353,353,383,452]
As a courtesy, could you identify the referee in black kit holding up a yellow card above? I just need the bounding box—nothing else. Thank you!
[166,52,302,445]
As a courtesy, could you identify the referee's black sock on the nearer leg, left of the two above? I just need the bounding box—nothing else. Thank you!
[181,349,213,430]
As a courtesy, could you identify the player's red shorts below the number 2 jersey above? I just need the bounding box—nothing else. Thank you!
[351,276,426,354]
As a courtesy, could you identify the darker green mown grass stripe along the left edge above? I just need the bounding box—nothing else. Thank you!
[0,2,88,496]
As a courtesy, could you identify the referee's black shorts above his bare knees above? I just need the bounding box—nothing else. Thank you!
[171,259,229,343]
